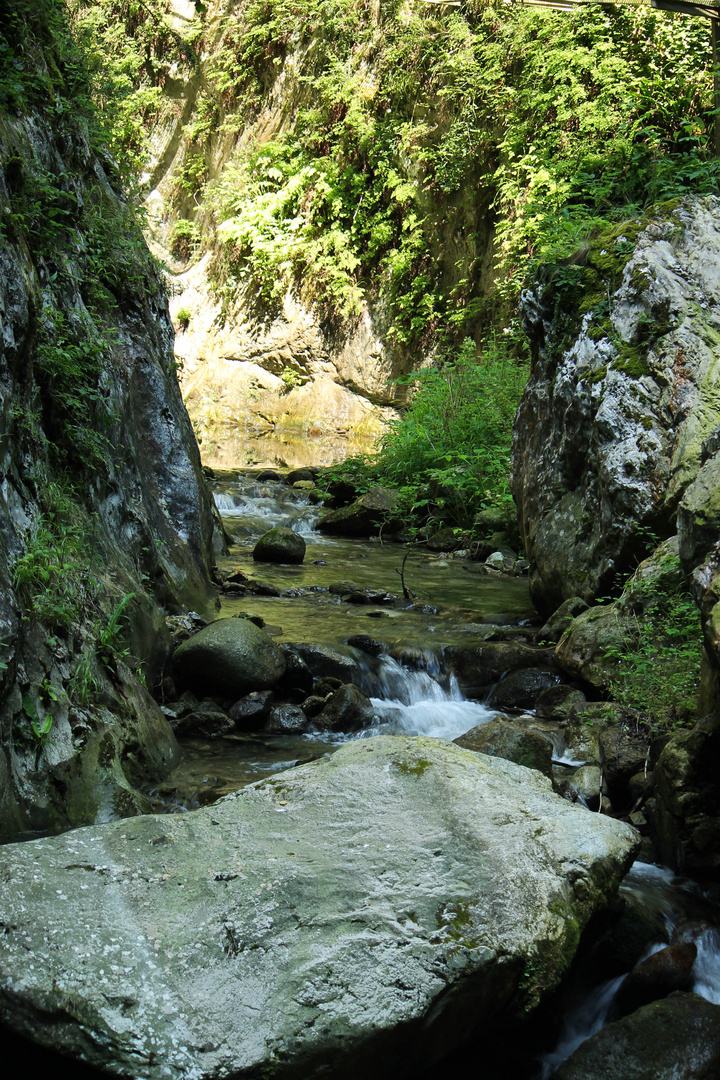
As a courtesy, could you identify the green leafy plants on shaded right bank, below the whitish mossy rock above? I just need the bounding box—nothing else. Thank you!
[607,555,703,728]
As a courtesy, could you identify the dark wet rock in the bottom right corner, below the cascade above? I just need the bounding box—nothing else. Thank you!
[555,994,720,1080]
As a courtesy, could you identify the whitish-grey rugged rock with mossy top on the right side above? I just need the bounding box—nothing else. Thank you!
[513,198,720,610]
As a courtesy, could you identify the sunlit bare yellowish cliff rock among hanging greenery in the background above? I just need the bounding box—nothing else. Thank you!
[131,0,493,465]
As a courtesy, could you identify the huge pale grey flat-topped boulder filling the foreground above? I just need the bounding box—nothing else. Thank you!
[0,737,637,1080]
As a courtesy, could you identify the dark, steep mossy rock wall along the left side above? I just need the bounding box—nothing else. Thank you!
[0,19,220,836]
